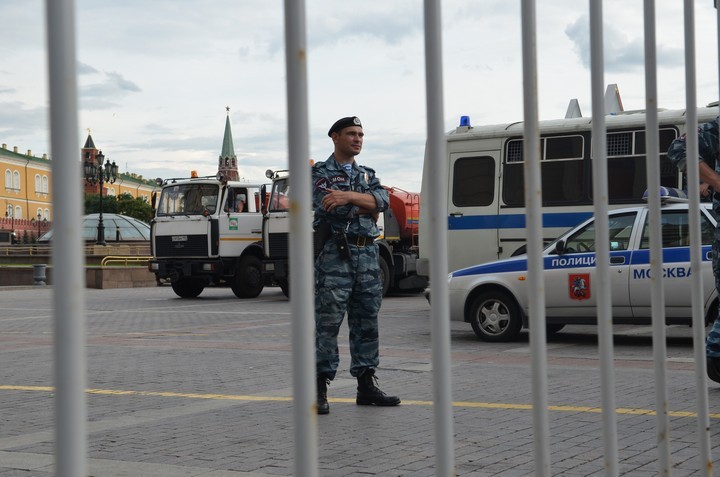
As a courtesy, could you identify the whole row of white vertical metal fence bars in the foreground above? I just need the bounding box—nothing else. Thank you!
[46,0,712,477]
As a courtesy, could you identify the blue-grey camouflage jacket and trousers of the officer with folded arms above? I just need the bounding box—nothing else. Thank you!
[312,155,389,380]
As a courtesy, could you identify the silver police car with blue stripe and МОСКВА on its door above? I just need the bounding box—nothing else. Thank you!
[448,188,717,341]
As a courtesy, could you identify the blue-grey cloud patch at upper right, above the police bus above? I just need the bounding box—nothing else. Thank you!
[565,14,683,73]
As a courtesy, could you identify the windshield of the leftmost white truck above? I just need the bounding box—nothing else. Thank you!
[157,184,220,217]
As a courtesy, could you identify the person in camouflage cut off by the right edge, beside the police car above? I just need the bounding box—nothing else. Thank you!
[668,118,720,383]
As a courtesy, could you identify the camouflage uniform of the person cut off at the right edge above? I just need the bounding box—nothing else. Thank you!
[668,118,720,358]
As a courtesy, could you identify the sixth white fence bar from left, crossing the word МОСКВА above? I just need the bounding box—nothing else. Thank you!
[644,0,672,475]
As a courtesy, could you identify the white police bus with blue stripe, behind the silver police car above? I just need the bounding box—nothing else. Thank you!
[418,89,718,276]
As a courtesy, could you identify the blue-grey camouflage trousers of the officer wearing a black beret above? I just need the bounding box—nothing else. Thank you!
[315,240,382,379]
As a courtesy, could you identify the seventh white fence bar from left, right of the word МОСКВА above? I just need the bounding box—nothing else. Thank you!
[684,0,712,470]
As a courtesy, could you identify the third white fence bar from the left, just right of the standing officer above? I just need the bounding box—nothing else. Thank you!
[423,0,455,477]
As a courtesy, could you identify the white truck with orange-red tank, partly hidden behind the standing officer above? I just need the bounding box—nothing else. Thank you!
[262,170,428,296]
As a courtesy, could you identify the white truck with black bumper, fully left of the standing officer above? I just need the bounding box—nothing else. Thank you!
[148,173,266,298]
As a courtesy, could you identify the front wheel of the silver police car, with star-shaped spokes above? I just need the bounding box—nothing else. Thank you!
[470,291,522,342]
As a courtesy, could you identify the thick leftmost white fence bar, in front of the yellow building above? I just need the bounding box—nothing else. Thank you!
[45,0,87,477]
